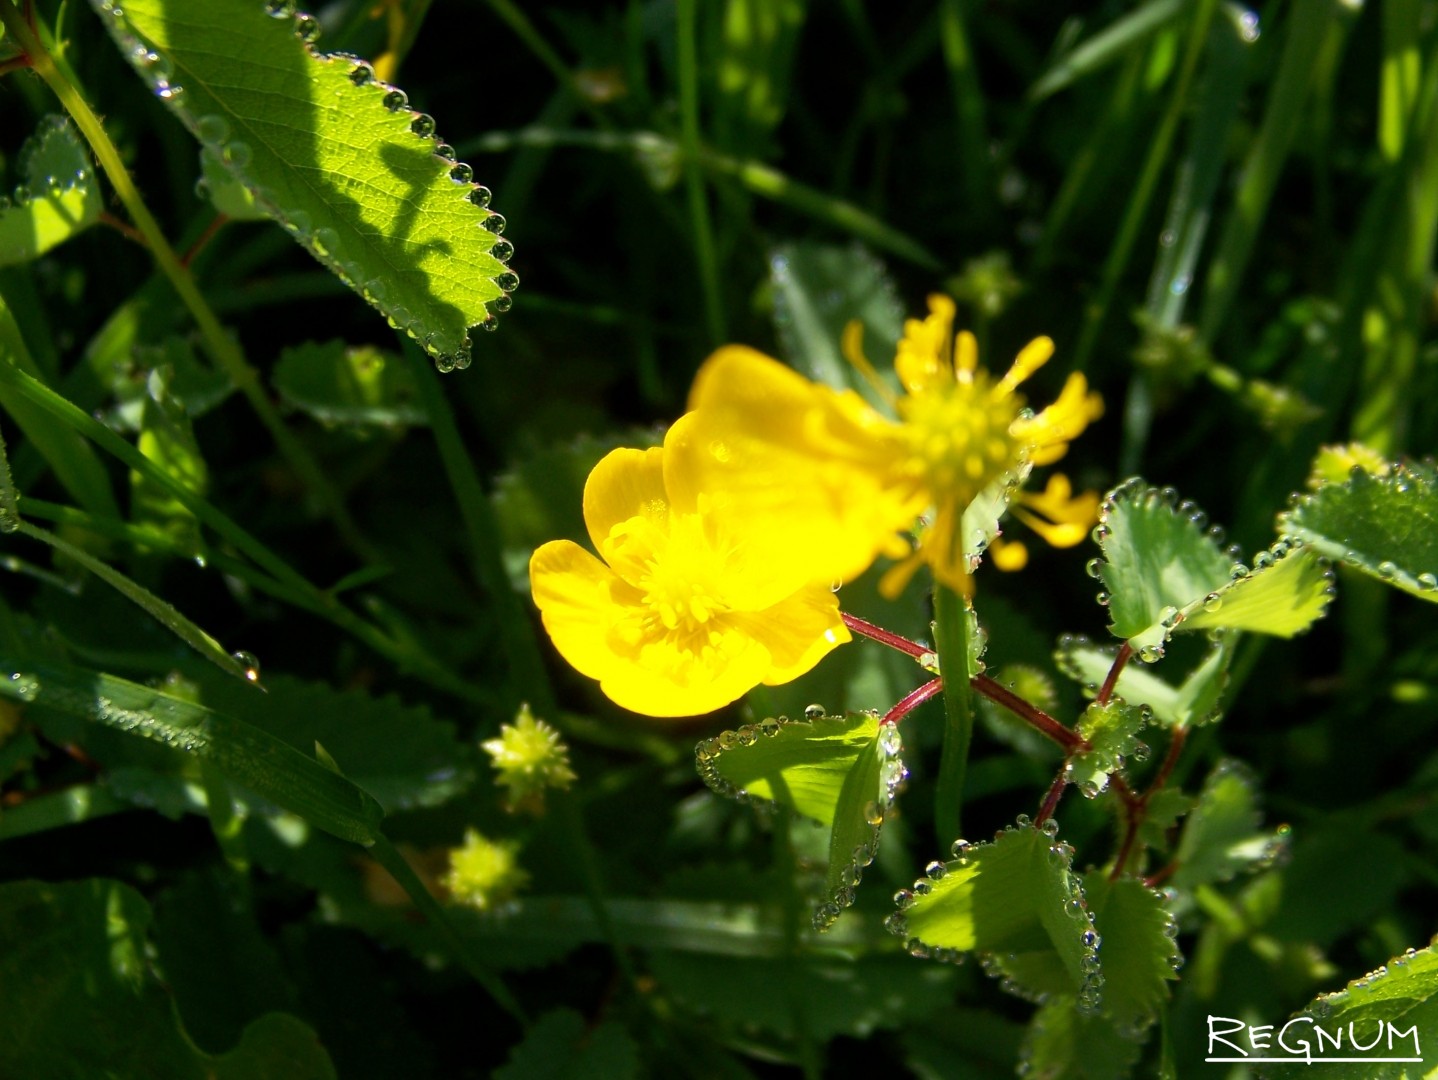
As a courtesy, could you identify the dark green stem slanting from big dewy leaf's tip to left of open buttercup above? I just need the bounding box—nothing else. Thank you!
[404,341,555,716]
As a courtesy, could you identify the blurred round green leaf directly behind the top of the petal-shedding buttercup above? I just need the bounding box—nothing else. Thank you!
[769,242,903,406]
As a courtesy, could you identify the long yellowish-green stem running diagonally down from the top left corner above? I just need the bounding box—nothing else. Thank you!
[0,0,378,561]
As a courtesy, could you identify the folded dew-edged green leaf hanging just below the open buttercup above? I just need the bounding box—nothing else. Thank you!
[695,709,907,930]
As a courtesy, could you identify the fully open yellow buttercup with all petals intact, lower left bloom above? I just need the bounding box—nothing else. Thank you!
[529,416,848,716]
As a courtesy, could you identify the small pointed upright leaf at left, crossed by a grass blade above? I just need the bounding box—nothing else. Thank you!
[129,367,208,560]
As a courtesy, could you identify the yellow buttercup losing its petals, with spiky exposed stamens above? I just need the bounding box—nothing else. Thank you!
[684,296,1103,595]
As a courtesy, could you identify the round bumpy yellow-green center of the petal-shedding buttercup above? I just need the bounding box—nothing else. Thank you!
[899,370,1024,508]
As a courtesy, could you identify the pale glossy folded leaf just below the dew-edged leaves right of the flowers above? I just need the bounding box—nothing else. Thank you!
[1054,637,1232,728]
